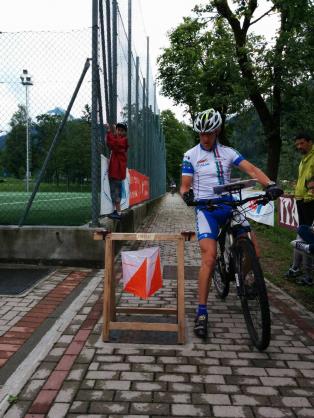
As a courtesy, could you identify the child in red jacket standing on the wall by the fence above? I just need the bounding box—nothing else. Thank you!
[106,123,129,220]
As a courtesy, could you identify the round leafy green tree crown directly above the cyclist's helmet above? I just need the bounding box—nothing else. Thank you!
[158,18,248,124]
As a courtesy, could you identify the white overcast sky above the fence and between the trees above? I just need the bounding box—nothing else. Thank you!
[0,0,274,124]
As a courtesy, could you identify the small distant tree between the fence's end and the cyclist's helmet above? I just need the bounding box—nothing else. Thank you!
[160,110,193,184]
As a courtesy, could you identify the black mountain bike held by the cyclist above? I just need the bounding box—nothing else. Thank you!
[192,180,271,350]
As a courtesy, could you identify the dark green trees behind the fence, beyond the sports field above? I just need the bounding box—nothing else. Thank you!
[1,106,91,184]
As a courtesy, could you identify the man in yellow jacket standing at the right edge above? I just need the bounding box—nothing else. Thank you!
[286,132,314,285]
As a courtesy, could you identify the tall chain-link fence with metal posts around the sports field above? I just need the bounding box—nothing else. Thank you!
[0,0,165,226]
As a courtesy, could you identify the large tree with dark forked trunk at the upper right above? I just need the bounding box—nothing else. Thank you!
[202,0,314,180]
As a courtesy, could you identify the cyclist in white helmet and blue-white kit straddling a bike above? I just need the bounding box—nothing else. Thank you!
[180,109,283,338]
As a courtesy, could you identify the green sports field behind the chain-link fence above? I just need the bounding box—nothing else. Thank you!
[0,192,91,226]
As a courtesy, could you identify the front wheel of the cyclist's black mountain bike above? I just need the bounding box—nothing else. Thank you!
[235,238,271,350]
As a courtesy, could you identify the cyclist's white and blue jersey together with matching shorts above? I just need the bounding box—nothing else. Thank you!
[182,142,248,240]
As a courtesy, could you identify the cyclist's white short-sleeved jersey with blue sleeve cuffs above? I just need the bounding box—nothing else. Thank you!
[182,142,244,200]
